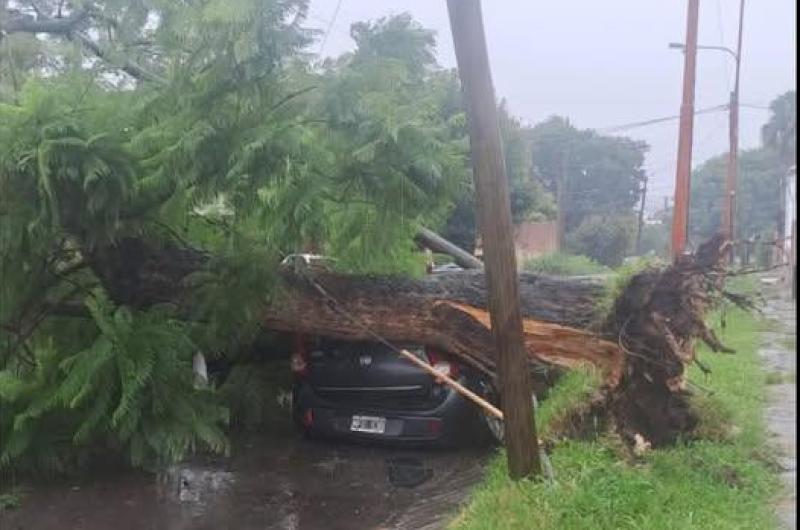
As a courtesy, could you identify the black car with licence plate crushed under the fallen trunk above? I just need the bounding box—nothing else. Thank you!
[291,336,502,446]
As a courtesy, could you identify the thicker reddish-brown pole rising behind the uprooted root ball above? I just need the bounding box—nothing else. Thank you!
[672,0,699,258]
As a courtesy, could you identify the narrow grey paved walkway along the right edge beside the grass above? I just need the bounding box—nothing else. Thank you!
[759,282,797,529]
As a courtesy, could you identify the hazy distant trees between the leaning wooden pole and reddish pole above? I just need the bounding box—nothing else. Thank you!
[445,113,647,261]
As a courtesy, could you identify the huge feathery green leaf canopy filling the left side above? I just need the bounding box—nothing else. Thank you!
[0,0,478,469]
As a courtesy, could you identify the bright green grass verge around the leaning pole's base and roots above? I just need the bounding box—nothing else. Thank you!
[450,311,777,530]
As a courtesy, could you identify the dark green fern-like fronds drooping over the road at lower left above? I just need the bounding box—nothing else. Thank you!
[0,290,228,470]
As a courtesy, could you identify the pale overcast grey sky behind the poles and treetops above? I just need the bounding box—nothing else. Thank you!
[310,0,796,209]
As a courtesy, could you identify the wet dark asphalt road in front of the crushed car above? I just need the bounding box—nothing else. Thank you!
[0,412,492,530]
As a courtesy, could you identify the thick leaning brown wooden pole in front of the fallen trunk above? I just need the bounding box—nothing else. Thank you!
[447,0,541,479]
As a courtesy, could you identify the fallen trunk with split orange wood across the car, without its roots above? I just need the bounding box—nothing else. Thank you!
[264,271,623,382]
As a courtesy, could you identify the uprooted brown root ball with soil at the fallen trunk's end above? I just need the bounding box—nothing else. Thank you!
[604,235,752,447]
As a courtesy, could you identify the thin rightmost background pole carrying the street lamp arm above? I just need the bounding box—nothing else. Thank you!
[722,0,744,251]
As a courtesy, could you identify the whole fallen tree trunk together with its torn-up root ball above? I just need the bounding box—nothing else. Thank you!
[87,236,729,446]
